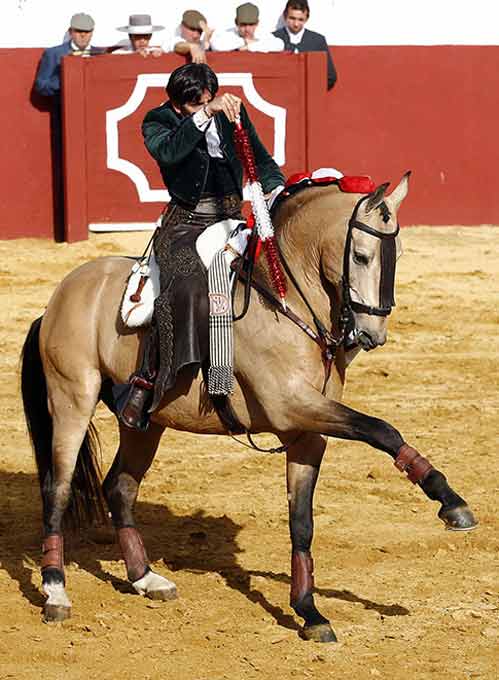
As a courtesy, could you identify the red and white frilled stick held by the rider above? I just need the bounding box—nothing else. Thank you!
[234,118,287,308]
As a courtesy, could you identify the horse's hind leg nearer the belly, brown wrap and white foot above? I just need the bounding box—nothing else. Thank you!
[104,423,177,600]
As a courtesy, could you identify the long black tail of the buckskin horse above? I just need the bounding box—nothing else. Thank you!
[21,317,106,529]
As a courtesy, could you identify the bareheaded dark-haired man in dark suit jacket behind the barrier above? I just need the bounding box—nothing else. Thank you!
[274,0,336,90]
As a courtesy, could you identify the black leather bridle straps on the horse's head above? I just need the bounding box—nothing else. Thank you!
[341,196,400,330]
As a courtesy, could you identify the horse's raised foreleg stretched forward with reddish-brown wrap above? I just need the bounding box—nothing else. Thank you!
[297,394,477,531]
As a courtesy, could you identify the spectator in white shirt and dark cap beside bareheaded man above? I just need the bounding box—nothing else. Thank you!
[210,2,284,52]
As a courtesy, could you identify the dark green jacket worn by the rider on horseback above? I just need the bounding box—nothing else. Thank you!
[142,102,284,207]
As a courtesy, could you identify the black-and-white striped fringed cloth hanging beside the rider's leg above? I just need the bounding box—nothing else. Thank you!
[208,250,234,396]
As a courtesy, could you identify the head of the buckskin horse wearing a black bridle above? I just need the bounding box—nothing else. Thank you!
[321,172,410,350]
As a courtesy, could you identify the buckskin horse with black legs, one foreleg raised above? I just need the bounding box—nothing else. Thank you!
[21,173,477,642]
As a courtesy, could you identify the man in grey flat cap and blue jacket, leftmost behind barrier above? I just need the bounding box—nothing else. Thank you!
[35,13,96,97]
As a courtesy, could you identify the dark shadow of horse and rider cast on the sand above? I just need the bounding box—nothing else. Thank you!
[0,471,410,630]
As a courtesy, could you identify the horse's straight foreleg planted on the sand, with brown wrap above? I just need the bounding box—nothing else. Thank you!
[286,433,336,642]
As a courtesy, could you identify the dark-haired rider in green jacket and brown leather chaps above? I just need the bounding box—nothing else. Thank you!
[119,64,284,429]
